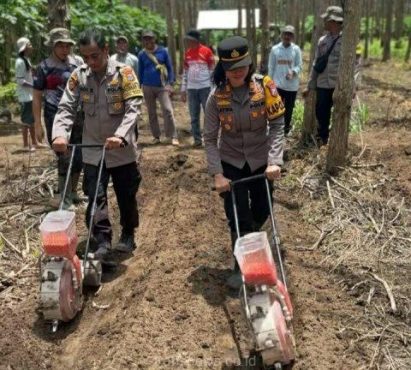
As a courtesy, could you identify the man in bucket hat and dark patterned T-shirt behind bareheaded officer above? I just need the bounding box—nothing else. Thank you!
[33,28,83,208]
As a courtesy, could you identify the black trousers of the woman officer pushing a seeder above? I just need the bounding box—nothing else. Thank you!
[221,162,272,234]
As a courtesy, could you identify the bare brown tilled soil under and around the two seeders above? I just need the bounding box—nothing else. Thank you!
[0,59,411,370]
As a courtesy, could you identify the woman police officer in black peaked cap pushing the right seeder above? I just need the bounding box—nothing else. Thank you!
[204,36,284,288]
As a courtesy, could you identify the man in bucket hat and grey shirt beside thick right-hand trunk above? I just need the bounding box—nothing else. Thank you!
[303,6,344,145]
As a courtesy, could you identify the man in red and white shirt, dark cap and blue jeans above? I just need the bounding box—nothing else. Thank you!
[181,30,214,146]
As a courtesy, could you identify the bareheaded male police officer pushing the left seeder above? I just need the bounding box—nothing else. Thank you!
[52,29,142,261]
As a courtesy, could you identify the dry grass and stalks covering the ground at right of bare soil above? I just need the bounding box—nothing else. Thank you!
[282,142,411,369]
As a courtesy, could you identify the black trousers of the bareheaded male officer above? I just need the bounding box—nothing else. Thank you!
[84,162,141,242]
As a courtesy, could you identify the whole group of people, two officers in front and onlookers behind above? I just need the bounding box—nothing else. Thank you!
[13,6,343,287]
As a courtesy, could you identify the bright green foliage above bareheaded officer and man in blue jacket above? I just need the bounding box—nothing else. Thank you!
[70,0,166,45]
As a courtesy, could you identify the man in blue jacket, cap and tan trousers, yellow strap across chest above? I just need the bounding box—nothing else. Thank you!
[138,31,179,146]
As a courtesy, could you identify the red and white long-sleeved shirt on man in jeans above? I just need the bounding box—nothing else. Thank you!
[181,44,214,91]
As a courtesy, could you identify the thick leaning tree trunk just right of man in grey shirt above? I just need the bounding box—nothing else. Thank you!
[326,0,361,174]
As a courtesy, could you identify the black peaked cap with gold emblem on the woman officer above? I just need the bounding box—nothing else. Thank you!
[217,36,252,71]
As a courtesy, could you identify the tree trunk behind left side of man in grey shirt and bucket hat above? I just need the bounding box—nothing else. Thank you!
[301,0,327,144]
